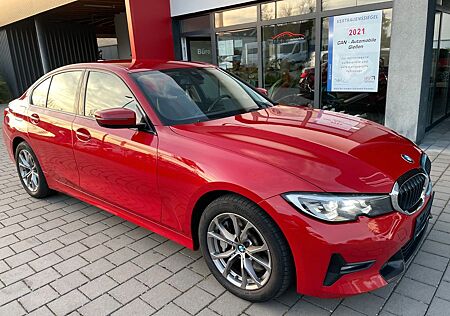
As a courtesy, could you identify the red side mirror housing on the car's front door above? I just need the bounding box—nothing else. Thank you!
[94,108,141,128]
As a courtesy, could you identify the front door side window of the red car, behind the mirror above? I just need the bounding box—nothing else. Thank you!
[84,71,139,122]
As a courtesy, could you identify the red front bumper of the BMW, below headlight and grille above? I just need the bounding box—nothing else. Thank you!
[261,196,432,298]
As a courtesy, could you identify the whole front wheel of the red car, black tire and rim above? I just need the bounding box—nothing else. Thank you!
[199,194,294,302]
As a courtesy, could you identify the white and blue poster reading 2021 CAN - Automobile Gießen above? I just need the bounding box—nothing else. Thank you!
[327,10,383,92]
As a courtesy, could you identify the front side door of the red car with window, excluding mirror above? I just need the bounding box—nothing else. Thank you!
[73,71,161,221]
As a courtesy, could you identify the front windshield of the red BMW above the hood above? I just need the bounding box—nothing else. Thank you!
[132,68,274,125]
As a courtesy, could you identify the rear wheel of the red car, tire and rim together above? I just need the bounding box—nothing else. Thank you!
[15,142,53,199]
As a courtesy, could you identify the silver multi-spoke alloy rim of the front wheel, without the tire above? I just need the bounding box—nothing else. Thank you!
[207,213,272,290]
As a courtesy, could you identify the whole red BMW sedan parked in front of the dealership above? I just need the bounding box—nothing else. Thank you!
[3,60,434,302]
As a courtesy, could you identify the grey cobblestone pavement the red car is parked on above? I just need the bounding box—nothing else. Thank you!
[0,104,450,316]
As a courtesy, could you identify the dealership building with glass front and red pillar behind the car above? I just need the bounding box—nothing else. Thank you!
[0,0,450,141]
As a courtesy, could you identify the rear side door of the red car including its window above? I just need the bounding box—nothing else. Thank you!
[28,70,83,187]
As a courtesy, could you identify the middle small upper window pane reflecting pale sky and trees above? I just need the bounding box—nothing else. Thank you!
[261,0,316,20]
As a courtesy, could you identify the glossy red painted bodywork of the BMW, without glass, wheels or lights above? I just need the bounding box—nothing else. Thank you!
[3,62,428,297]
